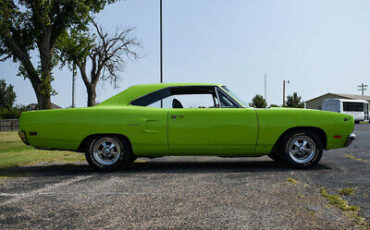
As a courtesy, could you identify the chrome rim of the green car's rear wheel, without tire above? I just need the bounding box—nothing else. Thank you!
[92,137,122,166]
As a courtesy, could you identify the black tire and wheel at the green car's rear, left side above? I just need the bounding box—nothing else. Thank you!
[85,135,132,171]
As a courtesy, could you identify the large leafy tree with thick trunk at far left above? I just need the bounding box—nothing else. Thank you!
[0,0,116,109]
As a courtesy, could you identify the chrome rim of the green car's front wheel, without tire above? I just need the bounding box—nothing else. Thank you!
[288,135,316,164]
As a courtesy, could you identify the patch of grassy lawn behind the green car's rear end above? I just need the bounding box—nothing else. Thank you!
[0,132,85,170]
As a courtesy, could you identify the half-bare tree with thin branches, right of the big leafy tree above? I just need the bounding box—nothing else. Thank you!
[58,20,139,106]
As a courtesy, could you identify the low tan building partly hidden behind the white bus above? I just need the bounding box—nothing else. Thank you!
[306,93,370,110]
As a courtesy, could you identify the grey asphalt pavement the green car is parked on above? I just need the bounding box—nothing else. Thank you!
[0,124,370,229]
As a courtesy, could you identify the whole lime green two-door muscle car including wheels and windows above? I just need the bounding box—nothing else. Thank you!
[19,83,355,170]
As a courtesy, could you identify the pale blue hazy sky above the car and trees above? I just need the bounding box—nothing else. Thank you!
[0,0,370,107]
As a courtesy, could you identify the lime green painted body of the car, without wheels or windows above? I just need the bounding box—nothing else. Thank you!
[19,83,354,165]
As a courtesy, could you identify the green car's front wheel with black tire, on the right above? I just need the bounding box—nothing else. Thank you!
[280,130,323,169]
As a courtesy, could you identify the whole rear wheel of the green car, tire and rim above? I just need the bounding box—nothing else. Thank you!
[85,136,132,171]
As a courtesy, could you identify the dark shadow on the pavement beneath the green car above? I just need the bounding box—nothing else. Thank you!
[0,160,331,178]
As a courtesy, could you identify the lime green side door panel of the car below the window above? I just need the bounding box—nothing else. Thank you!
[167,108,258,156]
